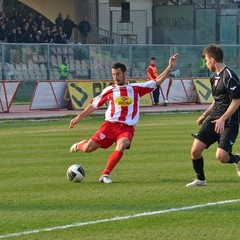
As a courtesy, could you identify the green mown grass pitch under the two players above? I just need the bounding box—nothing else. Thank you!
[0,113,240,240]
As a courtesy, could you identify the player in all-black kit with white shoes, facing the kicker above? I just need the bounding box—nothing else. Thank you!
[186,44,240,187]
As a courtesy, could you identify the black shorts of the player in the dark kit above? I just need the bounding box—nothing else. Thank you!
[194,119,239,153]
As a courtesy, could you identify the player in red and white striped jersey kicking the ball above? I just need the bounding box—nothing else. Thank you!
[69,54,177,183]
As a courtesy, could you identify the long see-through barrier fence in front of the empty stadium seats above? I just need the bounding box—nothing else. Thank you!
[0,43,240,99]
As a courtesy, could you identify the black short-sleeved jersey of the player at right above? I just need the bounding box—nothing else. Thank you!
[209,67,240,123]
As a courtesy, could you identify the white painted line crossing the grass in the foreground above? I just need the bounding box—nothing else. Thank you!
[0,199,240,239]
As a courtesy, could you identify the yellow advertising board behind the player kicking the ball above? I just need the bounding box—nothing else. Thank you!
[67,80,152,109]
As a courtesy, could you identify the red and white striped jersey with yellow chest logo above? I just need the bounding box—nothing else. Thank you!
[90,81,156,126]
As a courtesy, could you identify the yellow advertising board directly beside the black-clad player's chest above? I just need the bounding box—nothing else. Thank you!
[193,78,213,103]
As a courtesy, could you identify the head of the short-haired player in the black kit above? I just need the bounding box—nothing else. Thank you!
[203,44,223,72]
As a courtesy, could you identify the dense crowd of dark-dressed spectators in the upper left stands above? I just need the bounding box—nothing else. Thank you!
[0,10,81,44]
